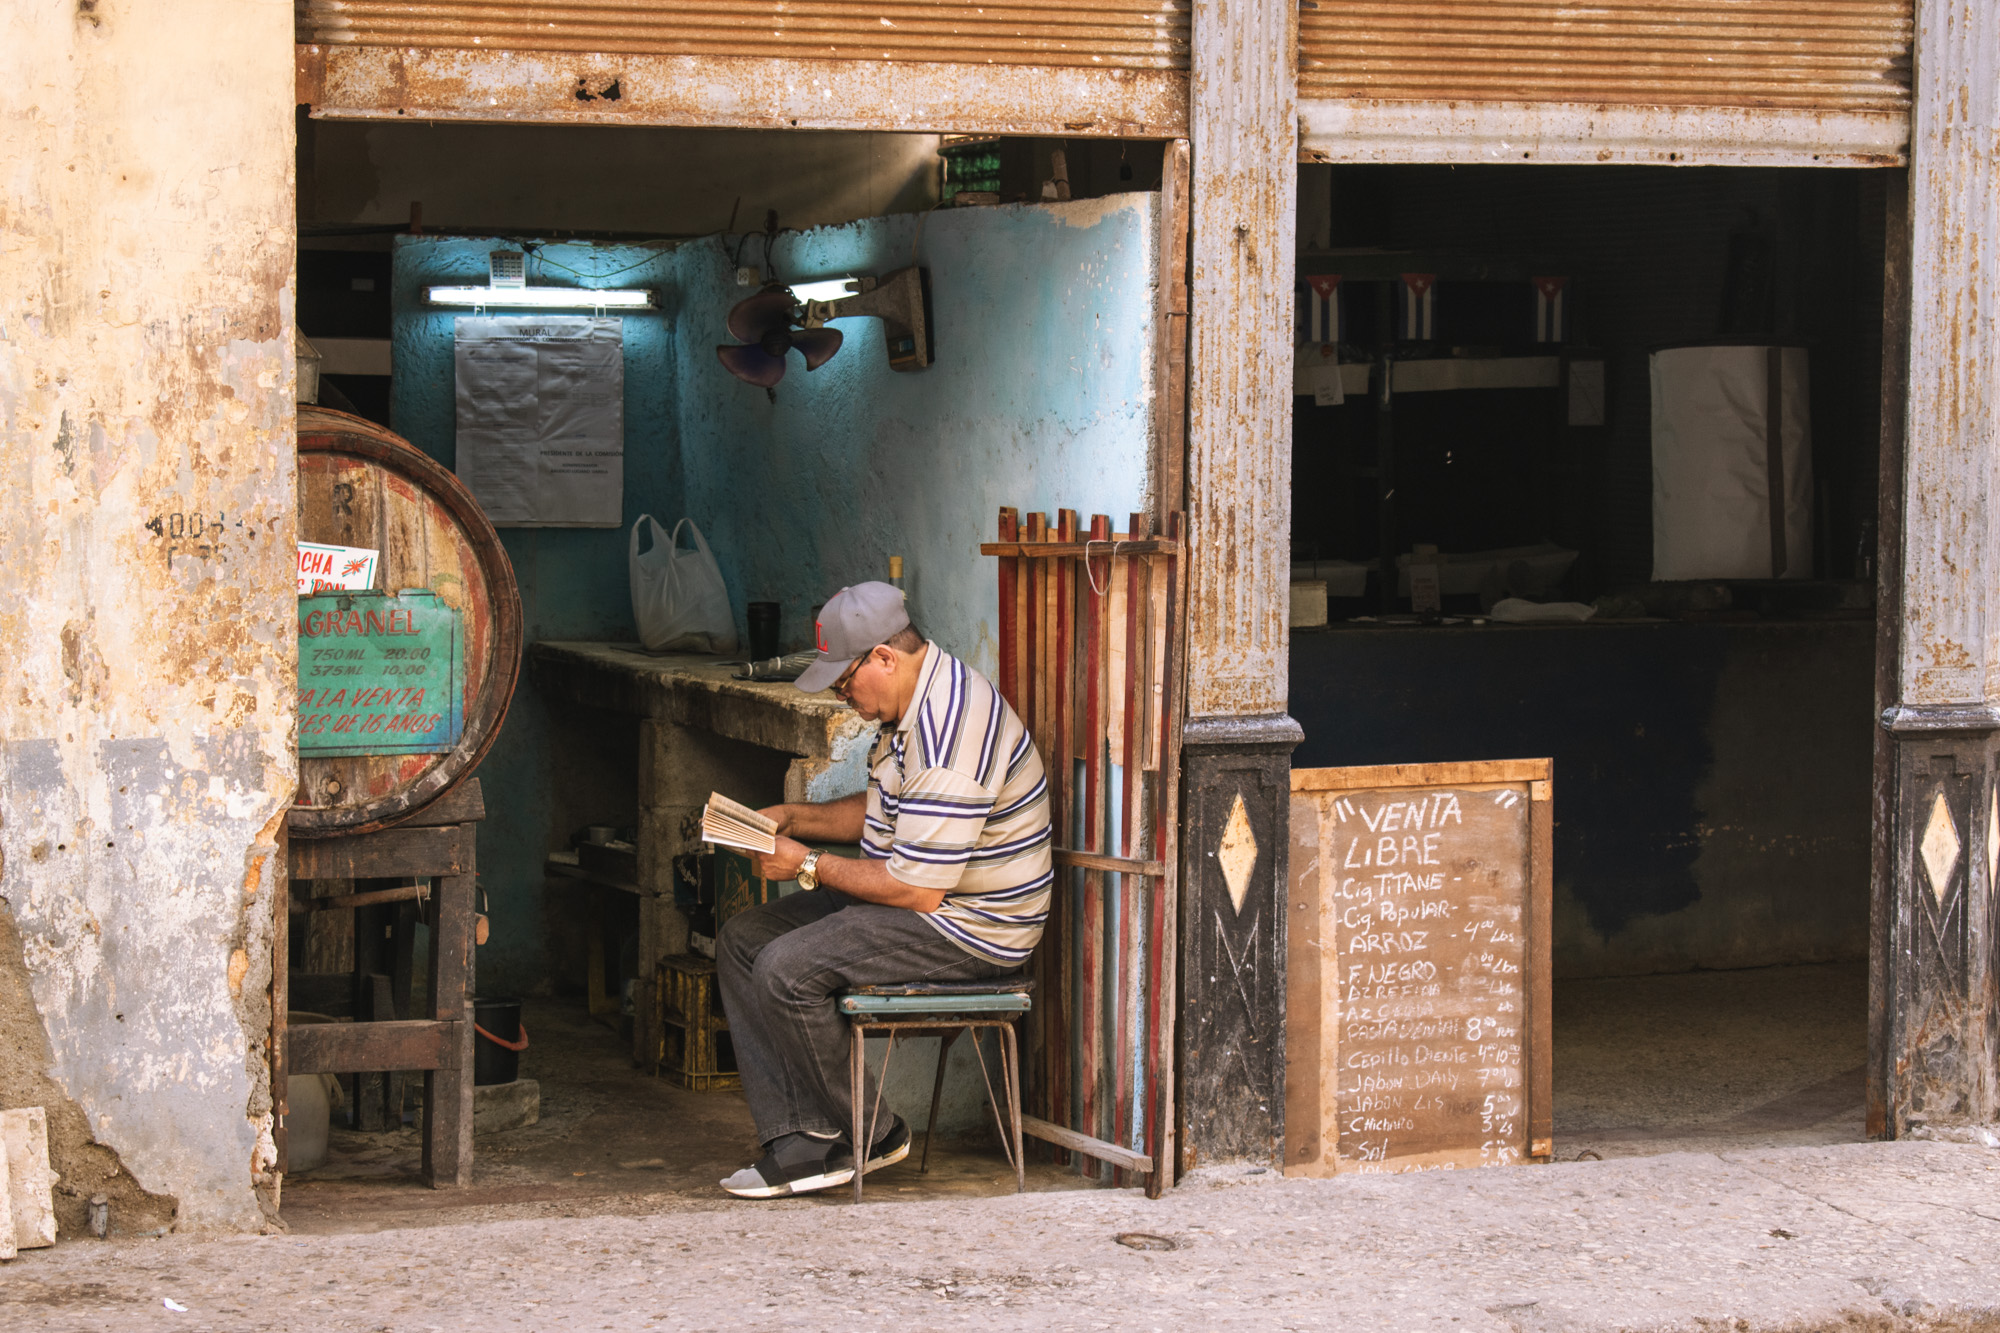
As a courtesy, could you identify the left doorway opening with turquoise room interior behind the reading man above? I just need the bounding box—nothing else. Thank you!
[284,114,1162,1229]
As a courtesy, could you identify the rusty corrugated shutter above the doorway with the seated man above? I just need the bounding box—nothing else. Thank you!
[298,0,1190,70]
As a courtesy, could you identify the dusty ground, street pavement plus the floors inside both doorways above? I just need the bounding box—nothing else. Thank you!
[11,967,1968,1333]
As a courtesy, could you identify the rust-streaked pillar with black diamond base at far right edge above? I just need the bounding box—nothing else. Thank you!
[1870,0,2000,1137]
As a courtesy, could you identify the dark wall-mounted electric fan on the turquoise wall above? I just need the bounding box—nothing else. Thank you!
[716,268,936,388]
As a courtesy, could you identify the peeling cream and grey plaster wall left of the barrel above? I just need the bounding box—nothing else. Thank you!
[0,0,296,1227]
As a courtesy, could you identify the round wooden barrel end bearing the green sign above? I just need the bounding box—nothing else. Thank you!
[288,404,522,837]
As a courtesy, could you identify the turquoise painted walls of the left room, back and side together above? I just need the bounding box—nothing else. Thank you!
[394,194,1158,993]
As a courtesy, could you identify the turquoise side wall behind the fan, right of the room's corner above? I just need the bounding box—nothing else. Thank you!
[674,194,1160,673]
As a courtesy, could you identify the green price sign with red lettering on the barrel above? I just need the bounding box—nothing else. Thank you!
[298,592,466,759]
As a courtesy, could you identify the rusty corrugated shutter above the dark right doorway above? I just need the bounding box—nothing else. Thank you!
[1298,0,1914,110]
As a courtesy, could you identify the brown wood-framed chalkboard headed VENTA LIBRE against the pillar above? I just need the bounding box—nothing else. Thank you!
[1284,759,1554,1175]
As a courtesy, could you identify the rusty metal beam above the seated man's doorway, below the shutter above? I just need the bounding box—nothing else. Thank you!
[298,44,1188,138]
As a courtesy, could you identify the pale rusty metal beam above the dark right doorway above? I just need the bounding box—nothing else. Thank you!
[1298,98,1910,166]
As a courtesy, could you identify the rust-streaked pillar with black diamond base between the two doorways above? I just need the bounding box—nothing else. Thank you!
[1178,0,1300,1169]
